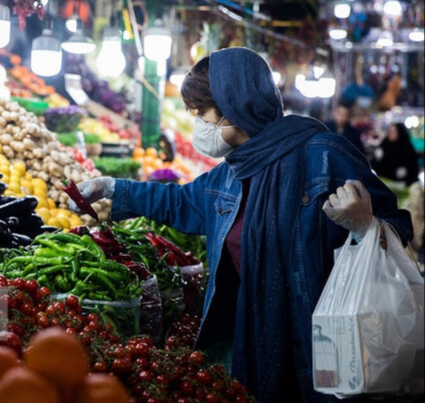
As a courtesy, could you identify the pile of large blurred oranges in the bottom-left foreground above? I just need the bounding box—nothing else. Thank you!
[0,327,129,403]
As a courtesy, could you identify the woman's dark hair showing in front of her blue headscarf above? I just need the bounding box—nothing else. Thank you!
[180,56,223,117]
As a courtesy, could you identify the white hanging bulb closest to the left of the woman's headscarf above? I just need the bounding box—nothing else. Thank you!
[144,18,171,61]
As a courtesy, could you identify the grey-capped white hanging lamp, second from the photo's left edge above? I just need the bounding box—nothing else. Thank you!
[31,28,62,77]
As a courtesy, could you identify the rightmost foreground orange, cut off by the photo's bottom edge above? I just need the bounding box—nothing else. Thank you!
[75,373,129,403]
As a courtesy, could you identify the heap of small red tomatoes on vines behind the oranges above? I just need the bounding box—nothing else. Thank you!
[0,275,255,403]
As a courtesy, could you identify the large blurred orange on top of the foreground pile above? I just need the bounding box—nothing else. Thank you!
[23,327,89,392]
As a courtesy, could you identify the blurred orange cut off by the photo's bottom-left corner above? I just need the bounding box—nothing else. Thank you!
[0,367,59,403]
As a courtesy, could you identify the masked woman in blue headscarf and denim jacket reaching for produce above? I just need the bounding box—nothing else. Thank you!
[69,47,412,403]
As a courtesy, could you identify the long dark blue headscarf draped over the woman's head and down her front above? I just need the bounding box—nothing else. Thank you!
[209,48,327,403]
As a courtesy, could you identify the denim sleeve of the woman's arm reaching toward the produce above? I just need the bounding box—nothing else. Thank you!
[111,174,208,235]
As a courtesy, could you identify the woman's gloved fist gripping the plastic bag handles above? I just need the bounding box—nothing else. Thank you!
[323,180,373,241]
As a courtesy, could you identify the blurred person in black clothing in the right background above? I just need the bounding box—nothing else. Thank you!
[370,122,419,186]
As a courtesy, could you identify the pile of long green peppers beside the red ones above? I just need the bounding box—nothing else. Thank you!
[0,233,141,301]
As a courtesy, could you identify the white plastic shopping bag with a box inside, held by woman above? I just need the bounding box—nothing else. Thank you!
[312,219,424,398]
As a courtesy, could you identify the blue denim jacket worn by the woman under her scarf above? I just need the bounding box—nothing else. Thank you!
[112,132,412,402]
